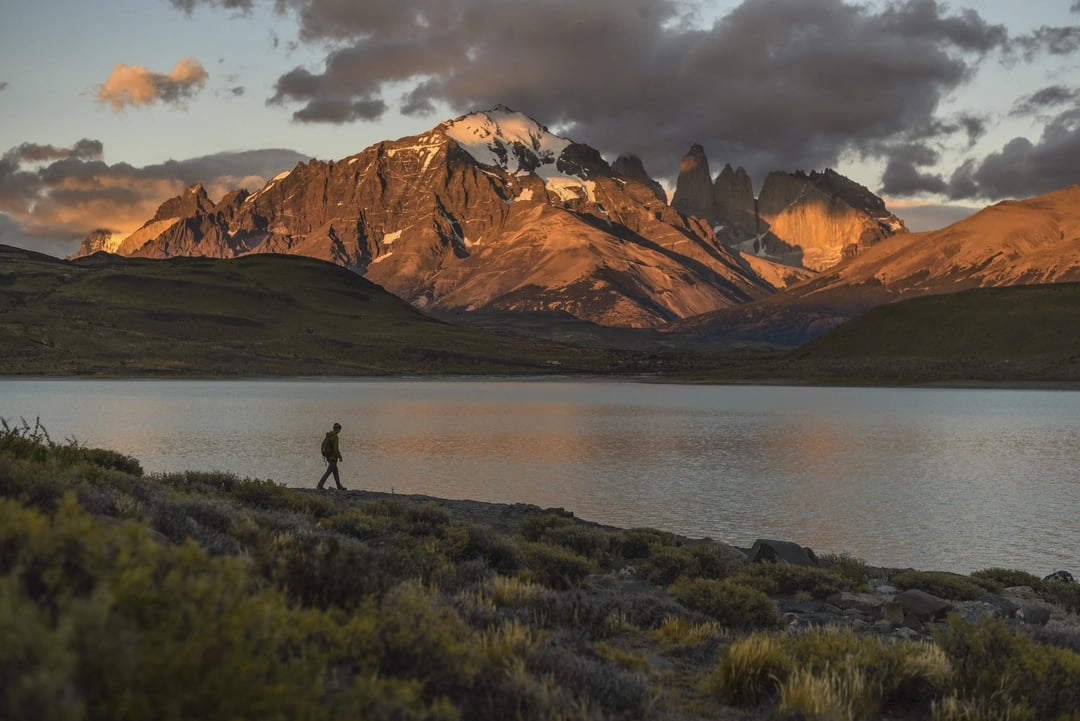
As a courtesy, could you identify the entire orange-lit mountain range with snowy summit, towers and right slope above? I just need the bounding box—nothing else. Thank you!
[76,106,1080,345]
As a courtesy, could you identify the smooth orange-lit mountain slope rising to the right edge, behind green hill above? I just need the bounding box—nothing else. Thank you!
[669,186,1080,345]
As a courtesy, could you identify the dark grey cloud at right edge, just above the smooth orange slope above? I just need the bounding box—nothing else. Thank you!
[948,106,1080,199]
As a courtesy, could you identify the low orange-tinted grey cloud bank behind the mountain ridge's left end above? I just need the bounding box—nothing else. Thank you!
[0,144,307,255]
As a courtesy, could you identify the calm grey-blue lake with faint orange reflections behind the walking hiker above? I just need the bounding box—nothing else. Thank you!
[0,380,1080,574]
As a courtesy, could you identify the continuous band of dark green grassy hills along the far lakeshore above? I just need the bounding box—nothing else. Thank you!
[8,241,1080,384]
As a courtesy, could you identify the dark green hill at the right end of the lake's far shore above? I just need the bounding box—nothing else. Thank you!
[783,283,1080,382]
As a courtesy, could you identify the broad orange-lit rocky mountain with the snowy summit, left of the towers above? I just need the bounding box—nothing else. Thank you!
[71,107,774,327]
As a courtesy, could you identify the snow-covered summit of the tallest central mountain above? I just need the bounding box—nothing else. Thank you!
[443,105,570,175]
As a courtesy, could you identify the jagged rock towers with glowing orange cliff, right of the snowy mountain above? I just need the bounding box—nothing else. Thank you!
[672,145,907,271]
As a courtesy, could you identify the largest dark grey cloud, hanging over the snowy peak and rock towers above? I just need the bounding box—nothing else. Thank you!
[172,0,1010,191]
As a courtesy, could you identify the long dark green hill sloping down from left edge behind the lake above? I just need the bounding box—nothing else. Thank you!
[0,246,623,376]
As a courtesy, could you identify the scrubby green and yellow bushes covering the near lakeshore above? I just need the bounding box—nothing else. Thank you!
[0,421,1080,721]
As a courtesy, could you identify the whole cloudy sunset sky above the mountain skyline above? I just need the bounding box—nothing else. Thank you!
[0,0,1080,256]
